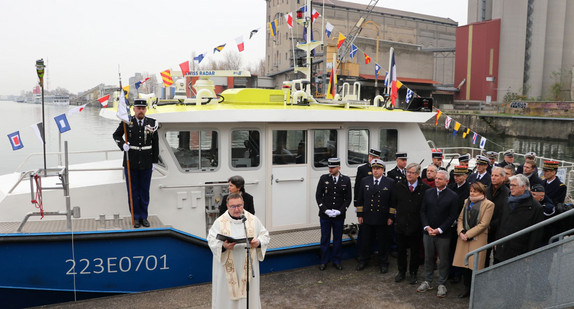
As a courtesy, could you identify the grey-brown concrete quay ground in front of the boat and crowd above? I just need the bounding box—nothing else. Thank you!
[40,258,468,309]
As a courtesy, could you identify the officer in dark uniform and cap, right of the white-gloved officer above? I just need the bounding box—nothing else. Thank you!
[355,159,395,274]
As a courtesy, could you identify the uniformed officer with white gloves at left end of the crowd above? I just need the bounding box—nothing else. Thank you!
[315,158,351,270]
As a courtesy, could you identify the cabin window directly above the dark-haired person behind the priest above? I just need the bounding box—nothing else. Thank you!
[231,130,261,168]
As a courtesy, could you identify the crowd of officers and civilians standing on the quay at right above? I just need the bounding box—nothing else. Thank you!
[316,149,568,298]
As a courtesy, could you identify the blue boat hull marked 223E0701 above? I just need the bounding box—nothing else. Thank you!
[0,228,355,308]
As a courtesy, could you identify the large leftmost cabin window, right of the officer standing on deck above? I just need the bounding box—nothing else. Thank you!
[165,130,219,171]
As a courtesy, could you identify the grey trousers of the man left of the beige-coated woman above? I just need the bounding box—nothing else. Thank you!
[423,233,450,285]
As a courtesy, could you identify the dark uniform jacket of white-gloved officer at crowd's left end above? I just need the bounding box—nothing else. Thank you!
[315,173,352,219]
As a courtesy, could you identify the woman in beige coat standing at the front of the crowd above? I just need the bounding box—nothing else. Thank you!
[452,182,494,298]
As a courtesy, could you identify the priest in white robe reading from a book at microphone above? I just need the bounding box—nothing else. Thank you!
[207,193,269,309]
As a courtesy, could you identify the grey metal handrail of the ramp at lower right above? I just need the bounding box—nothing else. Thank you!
[464,209,574,308]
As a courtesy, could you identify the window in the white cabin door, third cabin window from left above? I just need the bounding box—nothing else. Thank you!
[273,130,307,165]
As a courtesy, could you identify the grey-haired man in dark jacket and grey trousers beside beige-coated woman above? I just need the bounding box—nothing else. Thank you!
[417,171,458,298]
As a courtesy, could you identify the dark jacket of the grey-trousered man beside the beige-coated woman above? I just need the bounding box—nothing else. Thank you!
[420,187,458,237]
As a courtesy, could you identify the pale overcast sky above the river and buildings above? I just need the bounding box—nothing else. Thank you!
[0,0,467,95]
